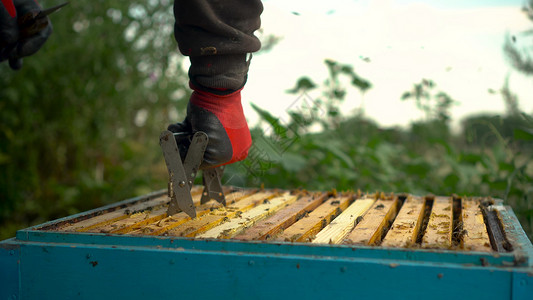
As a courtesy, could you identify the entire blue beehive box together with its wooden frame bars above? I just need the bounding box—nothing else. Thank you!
[0,187,533,299]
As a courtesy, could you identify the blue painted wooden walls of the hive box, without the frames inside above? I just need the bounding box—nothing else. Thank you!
[0,191,533,300]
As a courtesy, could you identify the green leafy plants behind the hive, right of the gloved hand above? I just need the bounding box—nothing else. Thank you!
[227,61,533,238]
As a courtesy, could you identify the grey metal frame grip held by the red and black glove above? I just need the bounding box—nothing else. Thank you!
[159,130,226,218]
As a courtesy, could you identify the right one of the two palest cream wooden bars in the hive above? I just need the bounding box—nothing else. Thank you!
[313,199,376,244]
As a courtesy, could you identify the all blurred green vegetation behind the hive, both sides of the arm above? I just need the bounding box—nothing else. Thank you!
[0,0,533,240]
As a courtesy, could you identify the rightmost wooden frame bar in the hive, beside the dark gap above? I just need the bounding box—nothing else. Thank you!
[462,199,492,252]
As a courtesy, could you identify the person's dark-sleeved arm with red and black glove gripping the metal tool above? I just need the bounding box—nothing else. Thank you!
[168,0,263,168]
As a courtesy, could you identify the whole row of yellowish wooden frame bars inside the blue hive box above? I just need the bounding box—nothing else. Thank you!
[43,186,500,252]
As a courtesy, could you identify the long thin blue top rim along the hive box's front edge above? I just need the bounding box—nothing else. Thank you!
[13,230,524,266]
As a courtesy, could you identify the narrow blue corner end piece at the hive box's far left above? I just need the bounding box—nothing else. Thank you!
[0,239,20,300]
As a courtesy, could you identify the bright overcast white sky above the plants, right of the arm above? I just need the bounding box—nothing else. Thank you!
[243,0,533,126]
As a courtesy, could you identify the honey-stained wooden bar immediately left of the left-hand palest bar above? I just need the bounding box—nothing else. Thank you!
[166,191,278,237]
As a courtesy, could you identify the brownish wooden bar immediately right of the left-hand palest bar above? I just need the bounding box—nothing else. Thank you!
[235,193,328,240]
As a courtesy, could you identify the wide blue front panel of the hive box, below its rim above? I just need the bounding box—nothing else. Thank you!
[21,243,516,300]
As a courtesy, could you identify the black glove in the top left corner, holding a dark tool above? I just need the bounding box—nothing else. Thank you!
[0,0,52,70]
